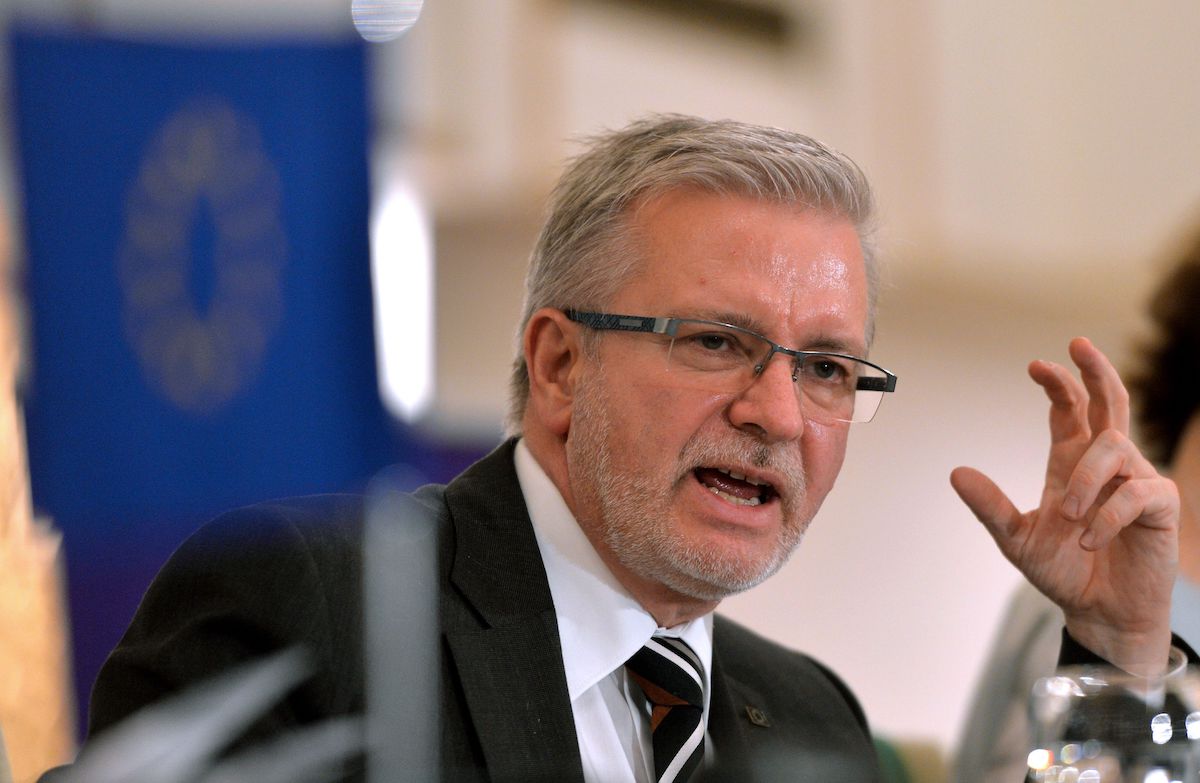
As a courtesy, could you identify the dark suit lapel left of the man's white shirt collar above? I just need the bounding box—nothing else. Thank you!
[443,441,583,782]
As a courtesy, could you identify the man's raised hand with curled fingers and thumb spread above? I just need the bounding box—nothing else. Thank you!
[950,337,1180,674]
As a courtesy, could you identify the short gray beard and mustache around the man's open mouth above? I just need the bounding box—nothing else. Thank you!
[571,379,809,600]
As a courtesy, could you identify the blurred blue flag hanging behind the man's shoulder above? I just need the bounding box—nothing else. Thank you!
[10,21,403,725]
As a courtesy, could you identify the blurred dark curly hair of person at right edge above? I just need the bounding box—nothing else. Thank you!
[1129,222,1200,465]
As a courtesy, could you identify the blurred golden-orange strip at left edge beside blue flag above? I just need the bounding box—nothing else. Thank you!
[0,201,74,783]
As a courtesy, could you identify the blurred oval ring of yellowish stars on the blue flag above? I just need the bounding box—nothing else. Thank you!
[118,100,286,413]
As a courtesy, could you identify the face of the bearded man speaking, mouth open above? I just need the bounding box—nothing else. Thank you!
[566,190,868,600]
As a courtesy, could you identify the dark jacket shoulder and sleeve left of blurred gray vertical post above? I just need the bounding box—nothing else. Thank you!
[89,488,440,736]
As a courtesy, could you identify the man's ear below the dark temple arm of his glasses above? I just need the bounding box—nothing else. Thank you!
[523,307,583,438]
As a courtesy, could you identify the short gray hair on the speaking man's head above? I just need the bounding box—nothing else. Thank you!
[508,114,880,435]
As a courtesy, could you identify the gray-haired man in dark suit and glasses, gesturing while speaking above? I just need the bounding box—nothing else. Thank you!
[82,115,1178,783]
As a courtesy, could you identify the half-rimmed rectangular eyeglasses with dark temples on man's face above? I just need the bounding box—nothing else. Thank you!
[563,310,896,423]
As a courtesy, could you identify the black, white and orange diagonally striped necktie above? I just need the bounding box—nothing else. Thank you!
[625,636,704,783]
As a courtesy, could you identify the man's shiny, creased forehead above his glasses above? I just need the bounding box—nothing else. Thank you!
[617,190,868,352]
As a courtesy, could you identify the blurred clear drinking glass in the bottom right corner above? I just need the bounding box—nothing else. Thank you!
[1027,651,1200,783]
